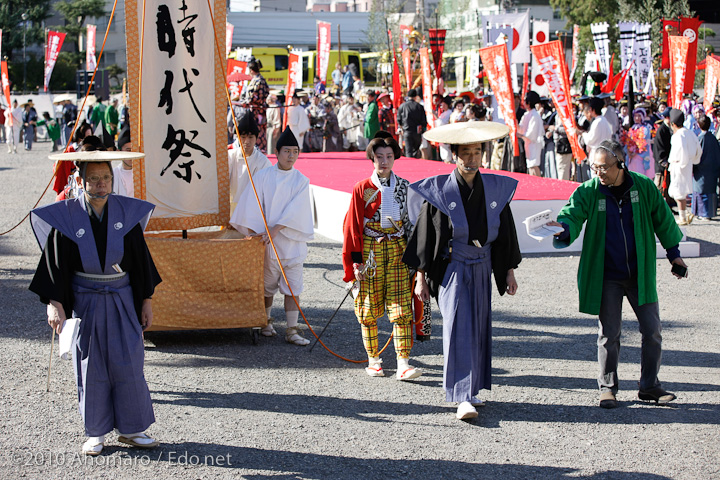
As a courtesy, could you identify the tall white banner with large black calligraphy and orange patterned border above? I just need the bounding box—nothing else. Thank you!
[125,0,230,230]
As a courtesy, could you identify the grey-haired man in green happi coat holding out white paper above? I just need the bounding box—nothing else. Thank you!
[549,140,687,408]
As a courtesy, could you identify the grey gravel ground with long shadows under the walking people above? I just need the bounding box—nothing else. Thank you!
[0,147,720,480]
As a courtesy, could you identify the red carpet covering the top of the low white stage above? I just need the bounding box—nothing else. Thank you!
[269,152,578,200]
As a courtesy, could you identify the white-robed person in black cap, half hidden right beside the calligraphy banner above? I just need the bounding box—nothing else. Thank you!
[228,110,272,212]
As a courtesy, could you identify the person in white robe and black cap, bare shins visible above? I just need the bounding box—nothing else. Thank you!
[230,127,314,346]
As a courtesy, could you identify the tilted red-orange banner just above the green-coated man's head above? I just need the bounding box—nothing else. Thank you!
[530,40,586,162]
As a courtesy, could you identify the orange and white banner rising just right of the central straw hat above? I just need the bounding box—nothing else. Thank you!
[480,43,516,154]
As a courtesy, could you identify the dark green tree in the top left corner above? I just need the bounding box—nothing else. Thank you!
[0,0,50,61]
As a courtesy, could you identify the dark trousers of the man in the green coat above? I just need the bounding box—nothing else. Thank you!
[597,279,662,393]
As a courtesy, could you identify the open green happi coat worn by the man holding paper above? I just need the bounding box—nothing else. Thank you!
[553,170,683,315]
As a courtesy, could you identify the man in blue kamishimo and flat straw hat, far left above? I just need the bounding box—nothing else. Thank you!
[30,151,161,455]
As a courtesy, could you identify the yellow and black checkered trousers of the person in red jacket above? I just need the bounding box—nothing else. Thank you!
[355,222,413,358]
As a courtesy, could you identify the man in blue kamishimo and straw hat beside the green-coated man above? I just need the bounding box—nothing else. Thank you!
[403,122,521,420]
